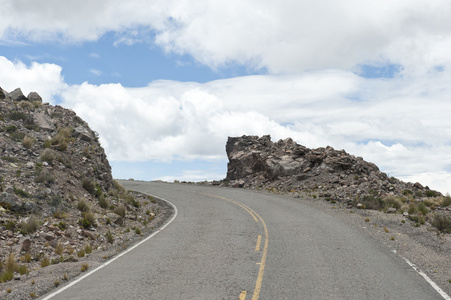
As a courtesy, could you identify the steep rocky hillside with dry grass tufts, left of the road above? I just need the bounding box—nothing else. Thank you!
[0,88,170,299]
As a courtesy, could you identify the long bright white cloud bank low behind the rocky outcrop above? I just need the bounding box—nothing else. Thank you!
[53,71,451,193]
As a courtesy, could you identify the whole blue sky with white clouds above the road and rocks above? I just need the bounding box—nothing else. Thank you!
[0,0,451,194]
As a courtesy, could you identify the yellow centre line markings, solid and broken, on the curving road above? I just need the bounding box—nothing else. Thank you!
[199,193,269,300]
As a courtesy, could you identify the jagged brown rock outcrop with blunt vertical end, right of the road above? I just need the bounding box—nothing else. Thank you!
[224,135,441,201]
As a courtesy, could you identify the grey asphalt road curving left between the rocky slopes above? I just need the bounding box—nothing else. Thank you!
[43,181,444,300]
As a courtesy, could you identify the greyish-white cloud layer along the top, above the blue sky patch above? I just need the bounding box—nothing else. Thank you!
[0,0,451,75]
